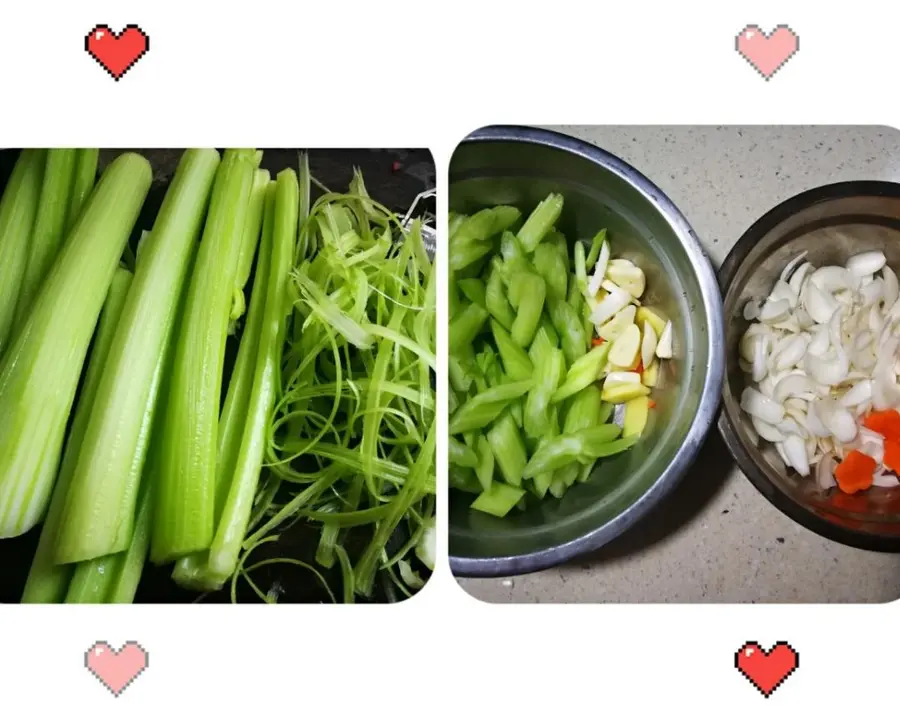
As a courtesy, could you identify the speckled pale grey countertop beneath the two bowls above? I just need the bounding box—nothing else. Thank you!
[460,126,900,603]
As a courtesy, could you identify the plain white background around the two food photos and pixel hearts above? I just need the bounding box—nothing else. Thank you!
[0,0,900,719]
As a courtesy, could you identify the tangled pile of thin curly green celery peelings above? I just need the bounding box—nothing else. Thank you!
[231,170,436,602]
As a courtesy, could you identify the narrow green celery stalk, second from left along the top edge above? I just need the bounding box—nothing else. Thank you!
[15,153,77,329]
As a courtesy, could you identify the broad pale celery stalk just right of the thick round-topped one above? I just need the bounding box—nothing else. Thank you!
[56,150,219,563]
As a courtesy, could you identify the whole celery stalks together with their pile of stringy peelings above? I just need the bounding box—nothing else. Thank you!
[0,149,435,603]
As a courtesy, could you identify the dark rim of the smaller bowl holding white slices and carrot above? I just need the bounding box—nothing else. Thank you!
[717,180,900,553]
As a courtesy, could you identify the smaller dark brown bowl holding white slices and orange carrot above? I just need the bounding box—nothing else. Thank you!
[719,182,900,552]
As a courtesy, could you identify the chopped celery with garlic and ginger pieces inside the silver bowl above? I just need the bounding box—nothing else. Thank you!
[449,193,675,517]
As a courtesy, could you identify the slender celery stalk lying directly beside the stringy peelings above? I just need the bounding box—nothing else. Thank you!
[209,169,300,581]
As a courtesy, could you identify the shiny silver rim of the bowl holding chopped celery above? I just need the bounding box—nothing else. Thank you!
[448,125,725,578]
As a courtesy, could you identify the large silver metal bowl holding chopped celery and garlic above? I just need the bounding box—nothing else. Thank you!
[450,127,724,577]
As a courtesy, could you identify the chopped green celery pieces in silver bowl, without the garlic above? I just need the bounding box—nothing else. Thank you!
[448,194,649,517]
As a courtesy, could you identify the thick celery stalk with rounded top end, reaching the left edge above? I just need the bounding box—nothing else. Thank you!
[0,153,153,538]
